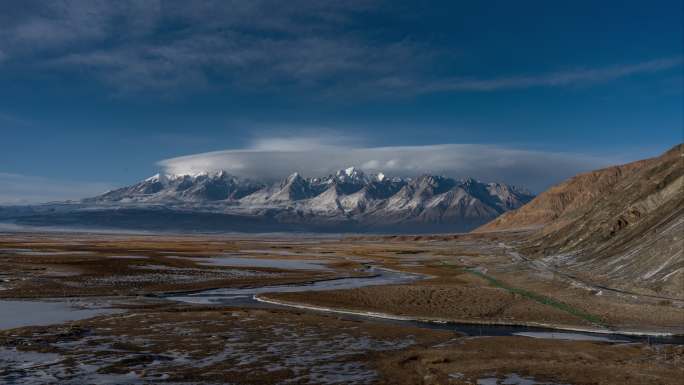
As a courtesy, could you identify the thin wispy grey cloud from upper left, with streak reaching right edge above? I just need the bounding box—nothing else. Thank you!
[0,0,682,97]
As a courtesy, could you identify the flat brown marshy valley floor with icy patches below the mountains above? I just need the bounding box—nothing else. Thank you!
[0,233,684,384]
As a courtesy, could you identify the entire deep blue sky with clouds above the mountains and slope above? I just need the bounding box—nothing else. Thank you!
[0,0,684,203]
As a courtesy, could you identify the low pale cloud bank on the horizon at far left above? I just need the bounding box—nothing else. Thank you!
[0,172,113,205]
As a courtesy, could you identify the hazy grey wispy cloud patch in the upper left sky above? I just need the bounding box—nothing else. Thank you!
[0,0,406,91]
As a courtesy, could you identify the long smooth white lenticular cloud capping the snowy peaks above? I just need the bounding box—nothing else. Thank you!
[158,139,611,191]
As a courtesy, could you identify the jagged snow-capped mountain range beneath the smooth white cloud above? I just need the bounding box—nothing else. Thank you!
[52,167,533,233]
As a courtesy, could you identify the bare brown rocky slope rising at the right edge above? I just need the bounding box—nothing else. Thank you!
[477,144,684,298]
